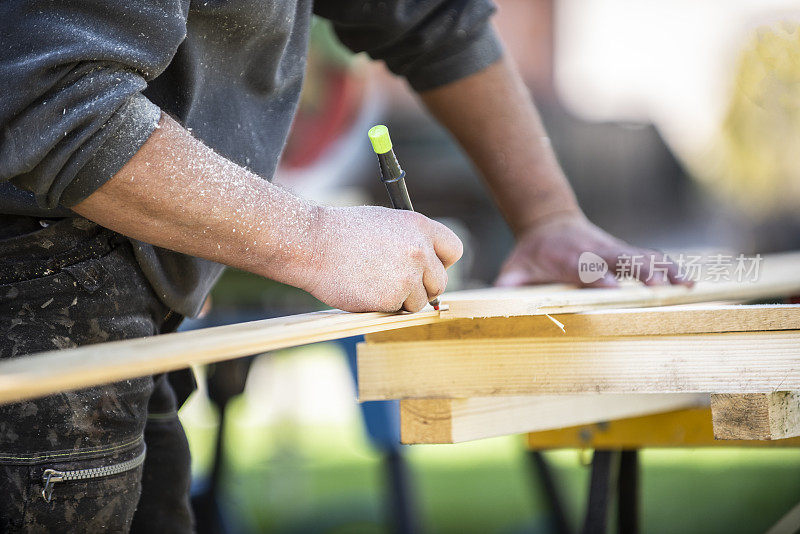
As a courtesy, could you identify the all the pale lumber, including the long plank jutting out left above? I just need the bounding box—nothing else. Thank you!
[0,254,800,443]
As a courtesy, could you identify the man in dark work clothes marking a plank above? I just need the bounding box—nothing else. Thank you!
[0,0,678,532]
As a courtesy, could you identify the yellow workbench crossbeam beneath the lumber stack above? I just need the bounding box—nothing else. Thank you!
[527,408,800,449]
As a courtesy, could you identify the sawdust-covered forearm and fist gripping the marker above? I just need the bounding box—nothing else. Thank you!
[73,116,462,311]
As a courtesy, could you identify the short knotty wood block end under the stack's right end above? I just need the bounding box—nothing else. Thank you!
[711,391,800,439]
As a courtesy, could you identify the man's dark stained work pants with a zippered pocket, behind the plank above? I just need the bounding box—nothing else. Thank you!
[0,216,192,533]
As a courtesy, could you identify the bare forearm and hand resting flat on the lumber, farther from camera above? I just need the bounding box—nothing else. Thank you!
[420,37,689,287]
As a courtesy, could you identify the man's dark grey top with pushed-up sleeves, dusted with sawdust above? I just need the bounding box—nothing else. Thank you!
[0,0,501,315]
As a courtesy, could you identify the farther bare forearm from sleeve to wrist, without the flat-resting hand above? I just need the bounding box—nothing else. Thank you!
[420,55,580,235]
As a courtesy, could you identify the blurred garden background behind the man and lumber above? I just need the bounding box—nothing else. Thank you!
[181,0,800,533]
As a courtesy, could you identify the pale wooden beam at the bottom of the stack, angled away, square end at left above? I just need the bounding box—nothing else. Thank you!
[400,393,708,444]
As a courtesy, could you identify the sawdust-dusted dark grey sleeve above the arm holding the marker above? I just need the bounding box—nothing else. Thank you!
[0,0,186,209]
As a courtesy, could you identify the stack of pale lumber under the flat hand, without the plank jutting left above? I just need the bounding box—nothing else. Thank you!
[358,255,800,443]
